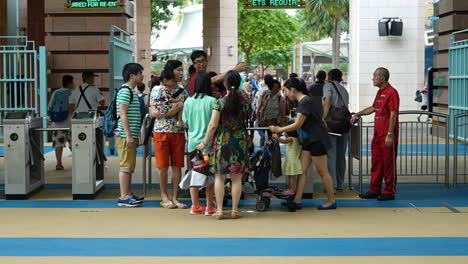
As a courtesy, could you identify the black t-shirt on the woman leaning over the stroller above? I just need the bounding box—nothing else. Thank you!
[297,96,330,149]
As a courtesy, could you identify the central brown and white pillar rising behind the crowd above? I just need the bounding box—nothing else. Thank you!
[203,0,238,73]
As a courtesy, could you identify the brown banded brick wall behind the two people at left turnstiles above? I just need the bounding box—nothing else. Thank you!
[45,0,135,110]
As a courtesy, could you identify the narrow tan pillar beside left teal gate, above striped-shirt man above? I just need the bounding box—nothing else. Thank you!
[135,0,151,91]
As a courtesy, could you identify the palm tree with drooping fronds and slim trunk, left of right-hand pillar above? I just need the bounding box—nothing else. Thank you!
[305,0,349,68]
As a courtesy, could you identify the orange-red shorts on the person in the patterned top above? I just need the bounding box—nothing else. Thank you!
[153,132,185,169]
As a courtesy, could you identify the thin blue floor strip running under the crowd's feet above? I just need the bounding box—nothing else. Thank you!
[0,200,468,210]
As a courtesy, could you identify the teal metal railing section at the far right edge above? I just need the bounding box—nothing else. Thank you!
[453,112,468,187]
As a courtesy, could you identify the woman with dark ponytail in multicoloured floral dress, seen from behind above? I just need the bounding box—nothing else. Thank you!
[197,71,250,220]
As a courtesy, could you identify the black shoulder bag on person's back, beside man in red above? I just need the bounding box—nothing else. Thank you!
[325,82,352,134]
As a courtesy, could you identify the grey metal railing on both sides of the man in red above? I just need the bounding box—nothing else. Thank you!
[348,111,450,191]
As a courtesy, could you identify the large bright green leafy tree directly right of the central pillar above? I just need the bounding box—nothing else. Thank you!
[238,0,297,65]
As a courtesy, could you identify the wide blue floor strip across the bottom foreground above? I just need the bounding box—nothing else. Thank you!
[0,237,468,257]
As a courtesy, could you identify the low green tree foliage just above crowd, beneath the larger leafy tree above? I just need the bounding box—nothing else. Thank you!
[252,48,293,77]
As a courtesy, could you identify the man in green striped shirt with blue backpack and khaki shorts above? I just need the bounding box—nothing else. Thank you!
[115,63,144,207]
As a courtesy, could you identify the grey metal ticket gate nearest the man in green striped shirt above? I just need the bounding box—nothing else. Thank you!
[71,111,107,200]
